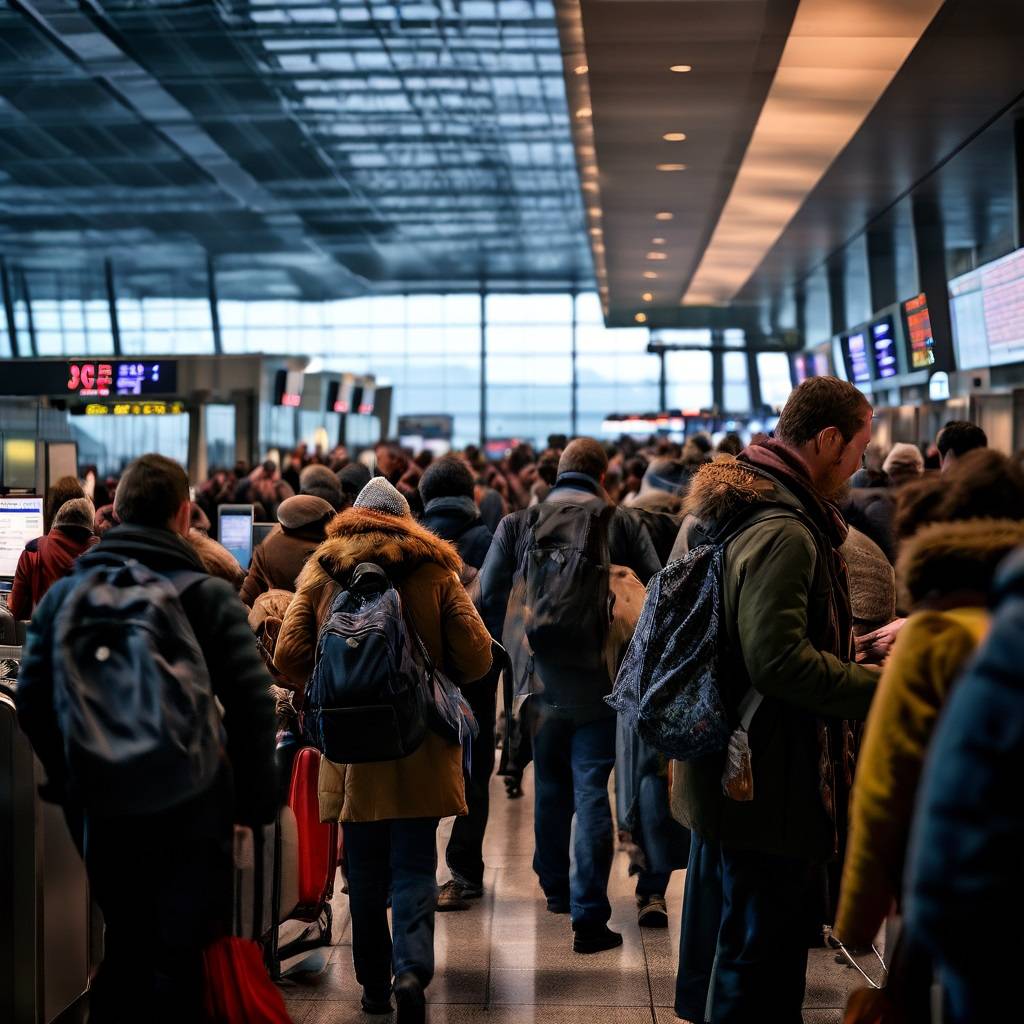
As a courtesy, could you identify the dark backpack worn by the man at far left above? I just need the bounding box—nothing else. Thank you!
[53,560,223,815]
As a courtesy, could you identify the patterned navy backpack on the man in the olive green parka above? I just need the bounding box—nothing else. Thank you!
[605,506,801,761]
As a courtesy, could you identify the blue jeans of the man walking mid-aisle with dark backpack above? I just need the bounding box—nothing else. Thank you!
[534,706,615,926]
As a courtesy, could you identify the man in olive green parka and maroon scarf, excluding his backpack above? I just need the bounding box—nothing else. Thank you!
[673,377,878,1024]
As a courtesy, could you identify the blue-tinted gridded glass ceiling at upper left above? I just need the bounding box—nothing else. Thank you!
[0,0,593,299]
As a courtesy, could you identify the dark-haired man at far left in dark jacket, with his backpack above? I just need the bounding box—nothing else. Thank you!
[17,455,276,1022]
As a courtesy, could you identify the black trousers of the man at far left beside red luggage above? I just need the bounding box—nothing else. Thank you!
[85,770,233,1024]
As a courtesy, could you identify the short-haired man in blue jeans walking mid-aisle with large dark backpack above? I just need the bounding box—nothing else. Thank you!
[480,437,660,953]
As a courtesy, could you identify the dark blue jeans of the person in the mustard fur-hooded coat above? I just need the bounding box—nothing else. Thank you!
[342,818,437,992]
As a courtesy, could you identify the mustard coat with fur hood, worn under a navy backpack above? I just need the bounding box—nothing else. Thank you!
[273,508,490,821]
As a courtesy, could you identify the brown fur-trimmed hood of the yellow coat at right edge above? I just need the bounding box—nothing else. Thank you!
[896,519,1024,608]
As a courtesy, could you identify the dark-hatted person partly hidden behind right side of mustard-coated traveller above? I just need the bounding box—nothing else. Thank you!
[420,455,502,912]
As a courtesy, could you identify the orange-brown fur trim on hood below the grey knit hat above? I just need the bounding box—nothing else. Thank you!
[297,508,462,590]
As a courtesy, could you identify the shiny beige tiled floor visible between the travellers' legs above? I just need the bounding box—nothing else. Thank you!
[284,772,859,1024]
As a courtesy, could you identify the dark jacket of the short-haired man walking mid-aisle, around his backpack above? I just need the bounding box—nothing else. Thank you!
[478,474,662,718]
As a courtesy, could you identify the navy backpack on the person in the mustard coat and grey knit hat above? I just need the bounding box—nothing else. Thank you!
[305,562,428,764]
